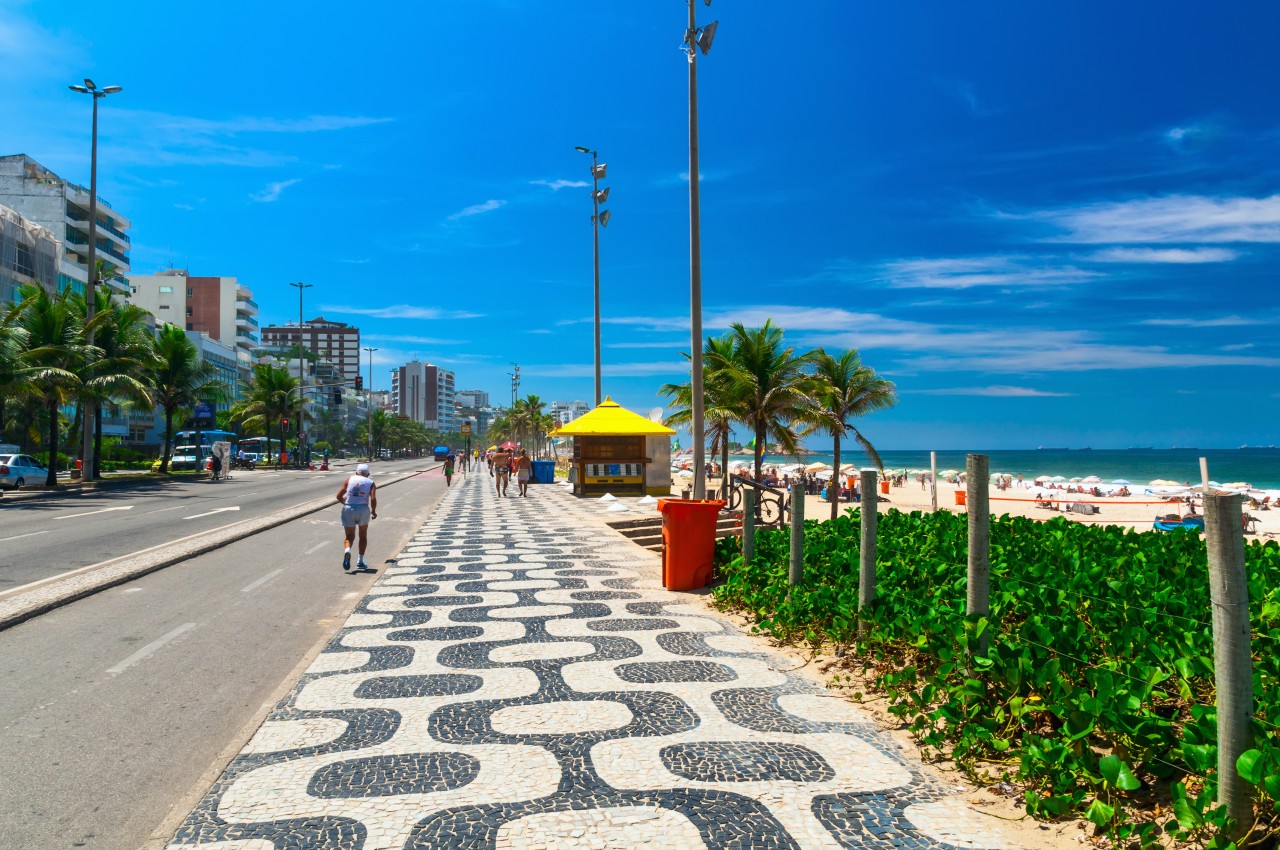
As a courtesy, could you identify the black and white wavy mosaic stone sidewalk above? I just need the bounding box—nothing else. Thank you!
[170,474,1007,850]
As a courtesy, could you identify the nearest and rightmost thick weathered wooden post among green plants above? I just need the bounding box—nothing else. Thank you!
[1204,493,1253,837]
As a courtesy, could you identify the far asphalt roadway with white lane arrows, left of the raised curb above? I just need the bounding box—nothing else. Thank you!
[0,458,438,591]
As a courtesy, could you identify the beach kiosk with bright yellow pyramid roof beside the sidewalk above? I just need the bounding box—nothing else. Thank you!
[549,398,676,497]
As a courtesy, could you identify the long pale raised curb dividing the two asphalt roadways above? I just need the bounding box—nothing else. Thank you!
[0,466,434,631]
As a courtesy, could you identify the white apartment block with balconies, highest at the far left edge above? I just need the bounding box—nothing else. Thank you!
[0,154,132,296]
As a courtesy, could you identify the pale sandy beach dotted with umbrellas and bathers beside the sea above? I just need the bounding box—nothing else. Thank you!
[671,477,1280,540]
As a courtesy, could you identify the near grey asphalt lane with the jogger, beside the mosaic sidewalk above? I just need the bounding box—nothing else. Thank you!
[0,465,458,850]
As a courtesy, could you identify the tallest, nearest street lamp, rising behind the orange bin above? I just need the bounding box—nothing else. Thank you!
[684,0,719,499]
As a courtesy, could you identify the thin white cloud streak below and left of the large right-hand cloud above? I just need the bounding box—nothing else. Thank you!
[883,255,1102,289]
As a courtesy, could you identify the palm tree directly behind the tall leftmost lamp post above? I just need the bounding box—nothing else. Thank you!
[73,289,155,479]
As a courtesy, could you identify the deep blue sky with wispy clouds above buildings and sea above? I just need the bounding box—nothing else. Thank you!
[0,0,1280,449]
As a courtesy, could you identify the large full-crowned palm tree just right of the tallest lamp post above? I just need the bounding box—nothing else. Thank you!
[695,319,814,479]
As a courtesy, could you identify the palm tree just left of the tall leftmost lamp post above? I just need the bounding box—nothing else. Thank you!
[18,287,87,486]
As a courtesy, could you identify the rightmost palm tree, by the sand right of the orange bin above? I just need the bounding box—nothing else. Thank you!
[809,348,897,520]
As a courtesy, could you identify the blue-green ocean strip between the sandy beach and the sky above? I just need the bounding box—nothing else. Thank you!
[731,444,1280,489]
